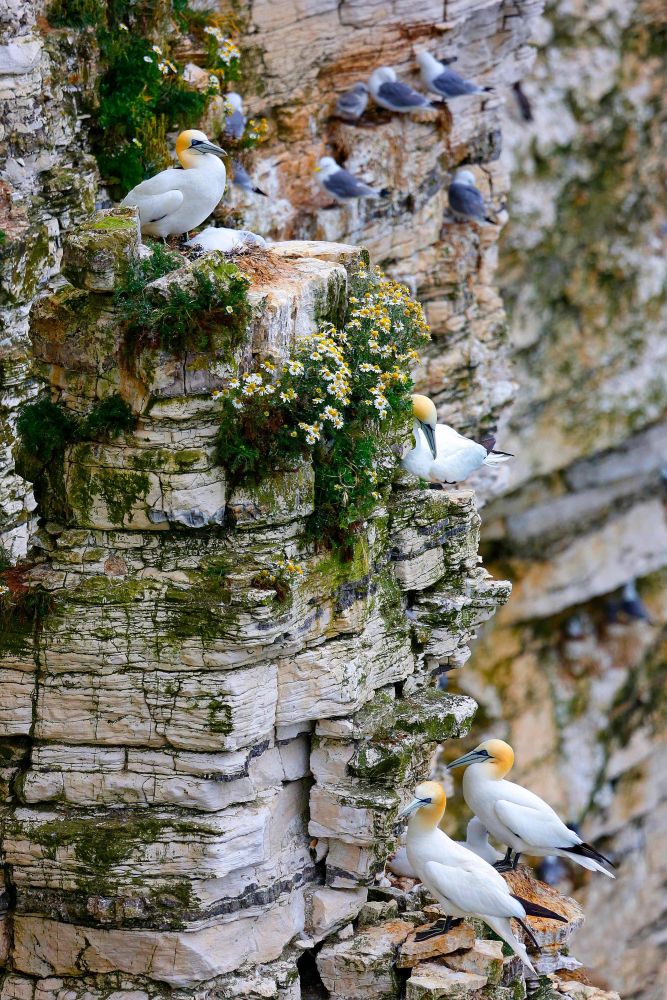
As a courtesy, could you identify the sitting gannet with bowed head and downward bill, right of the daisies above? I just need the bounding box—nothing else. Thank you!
[401,393,513,485]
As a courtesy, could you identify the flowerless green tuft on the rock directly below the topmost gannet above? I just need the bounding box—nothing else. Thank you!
[114,243,250,356]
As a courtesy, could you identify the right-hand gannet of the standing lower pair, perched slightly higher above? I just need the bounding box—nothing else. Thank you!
[448,740,614,878]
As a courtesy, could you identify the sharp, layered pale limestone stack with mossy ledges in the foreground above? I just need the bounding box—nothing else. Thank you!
[0,210,509,1000]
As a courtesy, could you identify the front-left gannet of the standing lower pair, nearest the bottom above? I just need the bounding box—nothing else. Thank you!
[400,781,565,975]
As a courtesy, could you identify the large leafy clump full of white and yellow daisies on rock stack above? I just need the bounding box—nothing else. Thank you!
[216,264,428,539]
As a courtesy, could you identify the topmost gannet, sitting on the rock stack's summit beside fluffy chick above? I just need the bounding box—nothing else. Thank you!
[121,129,226,239]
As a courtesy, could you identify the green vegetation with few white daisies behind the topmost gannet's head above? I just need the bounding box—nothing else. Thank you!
[47,0,256,198]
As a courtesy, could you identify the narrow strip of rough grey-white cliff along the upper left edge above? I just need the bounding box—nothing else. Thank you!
[0,0,97,560]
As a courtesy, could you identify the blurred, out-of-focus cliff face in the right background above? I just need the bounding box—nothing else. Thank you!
[462,2,667,998]
